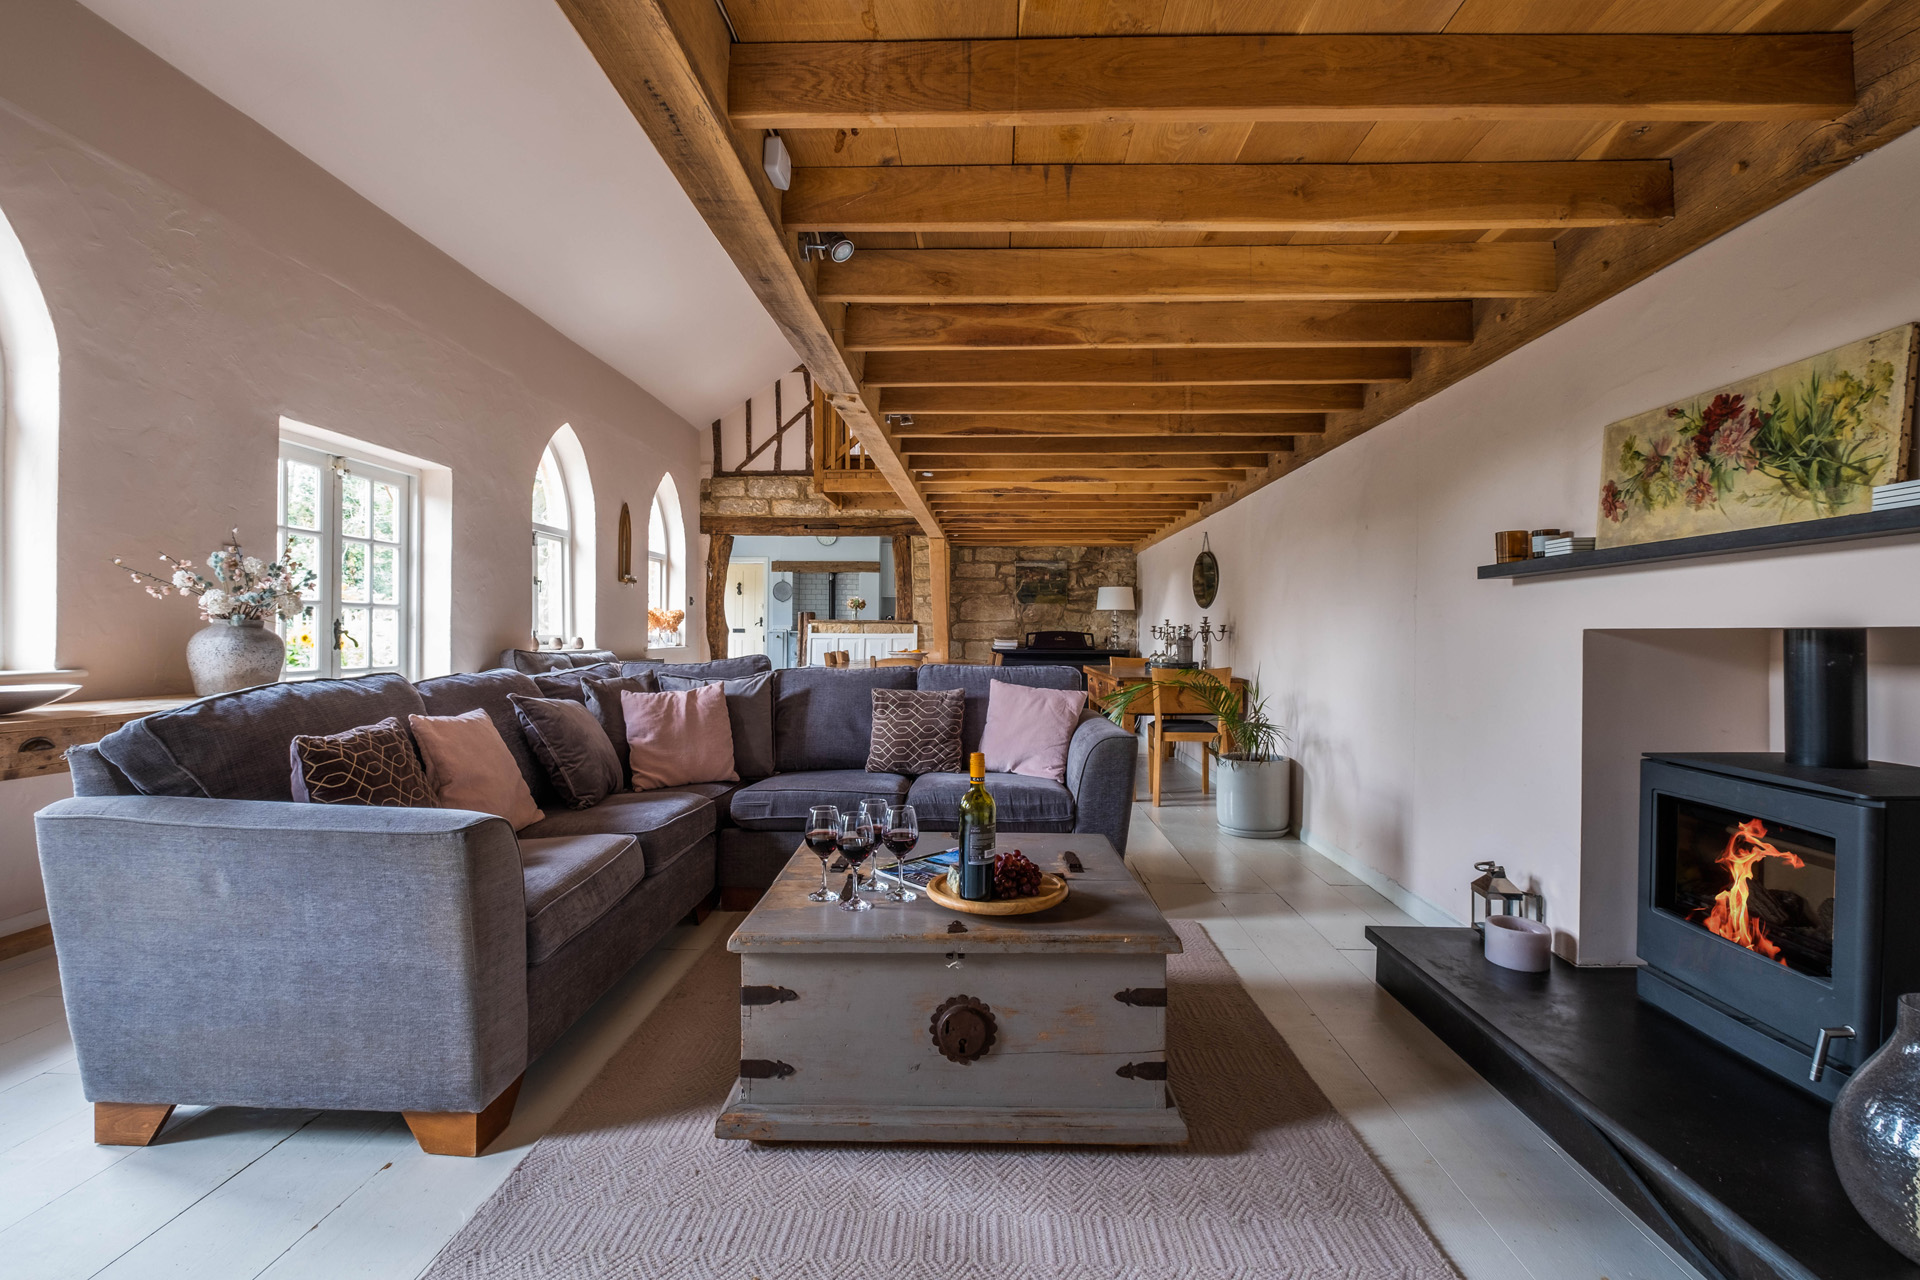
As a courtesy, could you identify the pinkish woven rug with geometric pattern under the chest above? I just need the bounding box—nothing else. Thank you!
[426,921,1455,1280]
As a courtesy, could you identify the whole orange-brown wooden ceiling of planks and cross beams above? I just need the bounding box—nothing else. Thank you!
[561,0,1905,543]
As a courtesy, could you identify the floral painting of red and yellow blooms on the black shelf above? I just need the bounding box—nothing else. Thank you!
[1597,324,1916,547]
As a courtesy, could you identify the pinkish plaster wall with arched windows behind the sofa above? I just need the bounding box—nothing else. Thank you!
[0,0,729,923]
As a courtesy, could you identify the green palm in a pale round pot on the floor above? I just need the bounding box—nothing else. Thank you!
[1106,670,1292,841]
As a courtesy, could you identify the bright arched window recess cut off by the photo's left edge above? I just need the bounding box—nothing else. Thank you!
[0,202,60,672]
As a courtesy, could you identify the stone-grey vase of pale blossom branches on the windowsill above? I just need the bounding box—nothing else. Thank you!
[113,530,317,697]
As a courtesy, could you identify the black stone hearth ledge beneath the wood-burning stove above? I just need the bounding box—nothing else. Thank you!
[1367,925,1920,1280]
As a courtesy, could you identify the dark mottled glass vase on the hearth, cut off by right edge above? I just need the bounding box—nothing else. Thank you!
[1826,996,1920,1263]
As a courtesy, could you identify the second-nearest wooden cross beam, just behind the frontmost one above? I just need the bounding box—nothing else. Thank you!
[780,159,1674,232]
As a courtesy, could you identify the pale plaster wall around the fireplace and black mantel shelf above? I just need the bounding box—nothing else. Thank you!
[1140,127,1920,956]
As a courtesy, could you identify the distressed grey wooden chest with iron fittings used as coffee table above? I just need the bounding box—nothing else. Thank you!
[714,833,1187,1144]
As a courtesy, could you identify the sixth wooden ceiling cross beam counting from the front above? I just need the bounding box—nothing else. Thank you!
[879,382,1367,416]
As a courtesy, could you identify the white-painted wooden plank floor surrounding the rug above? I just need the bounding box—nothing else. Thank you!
[0,764,1697,1280]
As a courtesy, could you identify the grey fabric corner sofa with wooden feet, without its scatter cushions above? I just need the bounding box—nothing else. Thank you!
[36,656,1135,1155]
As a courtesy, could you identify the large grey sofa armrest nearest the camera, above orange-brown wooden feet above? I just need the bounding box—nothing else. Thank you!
[35,796,526,1111]
